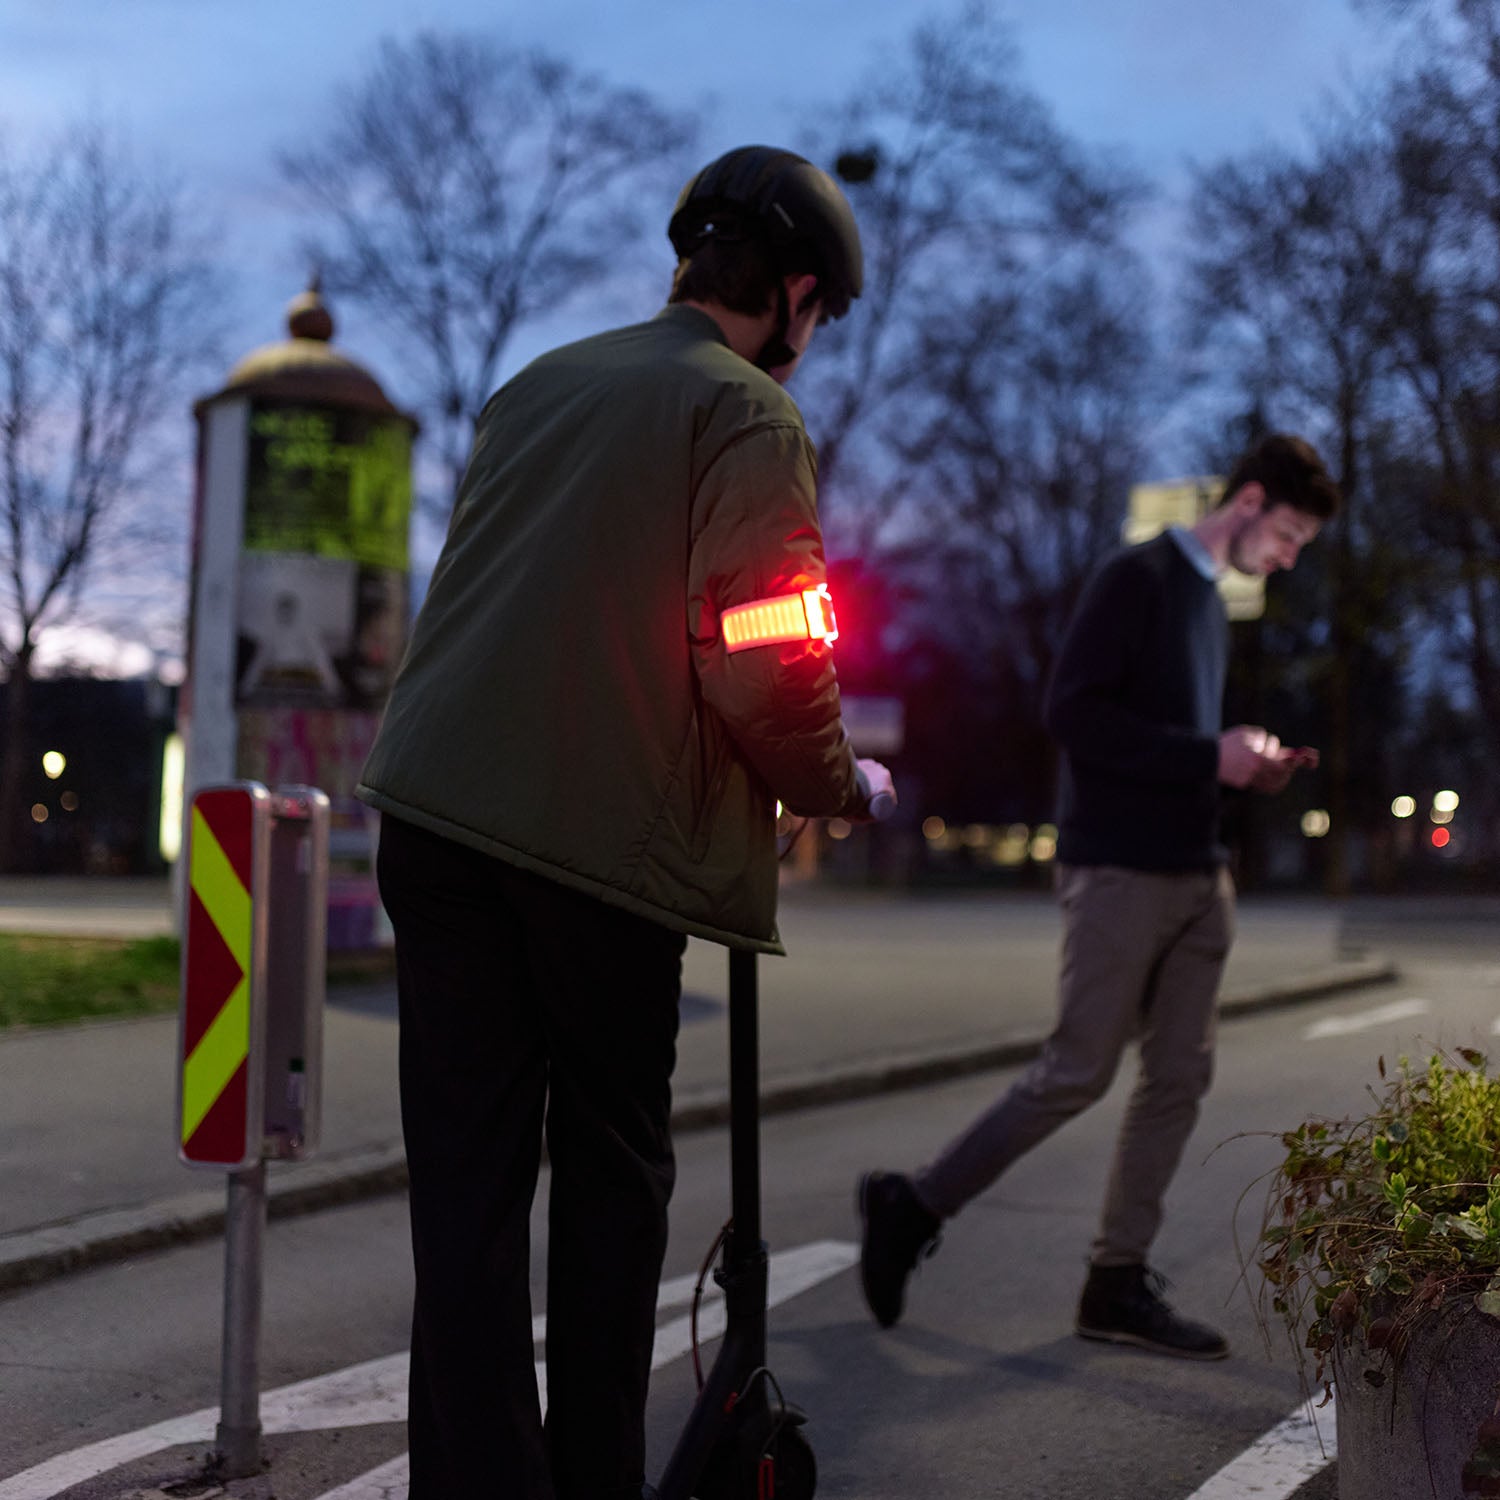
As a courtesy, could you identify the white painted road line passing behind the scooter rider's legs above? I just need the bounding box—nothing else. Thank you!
[0,1241,860,1500]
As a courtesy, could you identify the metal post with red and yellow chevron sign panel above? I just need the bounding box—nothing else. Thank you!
[177,782,329,1478]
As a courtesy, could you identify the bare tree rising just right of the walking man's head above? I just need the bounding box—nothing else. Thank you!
[1185,116,1412,894]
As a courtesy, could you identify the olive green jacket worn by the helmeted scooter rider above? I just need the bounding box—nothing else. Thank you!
[359,306,869,953]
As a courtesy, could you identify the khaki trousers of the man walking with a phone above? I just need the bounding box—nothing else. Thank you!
[914,866,1235,1266]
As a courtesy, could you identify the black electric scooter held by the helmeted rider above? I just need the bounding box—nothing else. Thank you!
[657,792,896,1500]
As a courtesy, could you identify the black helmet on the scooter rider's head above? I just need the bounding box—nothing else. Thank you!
[666,146,864,318]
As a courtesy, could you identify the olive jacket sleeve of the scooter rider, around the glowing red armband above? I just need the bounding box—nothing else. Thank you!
[687,422,869,818]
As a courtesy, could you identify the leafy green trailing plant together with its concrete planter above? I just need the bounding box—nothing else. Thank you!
[1257,1049,1500,1500]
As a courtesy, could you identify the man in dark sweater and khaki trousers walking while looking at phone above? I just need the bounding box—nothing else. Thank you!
[858,435,1340,1359]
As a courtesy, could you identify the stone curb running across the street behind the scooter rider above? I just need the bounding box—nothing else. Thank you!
[0,959,1400,1293]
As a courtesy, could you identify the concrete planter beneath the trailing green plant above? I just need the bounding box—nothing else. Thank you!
[1334,1301,1500,1500]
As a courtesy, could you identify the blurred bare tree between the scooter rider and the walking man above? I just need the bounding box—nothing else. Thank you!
[774,3,1151,816]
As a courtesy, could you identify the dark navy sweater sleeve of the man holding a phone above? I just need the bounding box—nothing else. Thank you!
[1043,554,1218,783]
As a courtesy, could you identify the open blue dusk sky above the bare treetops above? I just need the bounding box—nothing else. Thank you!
[0,0,1422,669]
